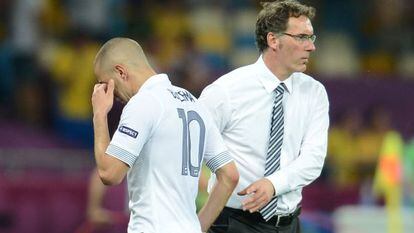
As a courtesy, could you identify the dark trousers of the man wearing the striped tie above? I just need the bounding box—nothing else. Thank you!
[208,207,300,233]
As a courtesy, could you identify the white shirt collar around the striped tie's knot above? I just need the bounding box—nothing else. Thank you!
[255,56,293,94]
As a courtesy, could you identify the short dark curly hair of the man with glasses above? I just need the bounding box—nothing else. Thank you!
[256,0,315,52]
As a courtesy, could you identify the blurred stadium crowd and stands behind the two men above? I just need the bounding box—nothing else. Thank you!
[0,0,414,233]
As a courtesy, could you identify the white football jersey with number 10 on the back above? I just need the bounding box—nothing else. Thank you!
[106,74,231,233]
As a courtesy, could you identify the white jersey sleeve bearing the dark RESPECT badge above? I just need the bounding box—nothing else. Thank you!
[106,93,162,167]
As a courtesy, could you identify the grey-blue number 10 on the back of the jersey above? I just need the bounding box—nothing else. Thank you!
[177,108,206,177]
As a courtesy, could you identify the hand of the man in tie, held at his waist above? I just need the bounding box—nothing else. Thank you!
[237,178,275,213]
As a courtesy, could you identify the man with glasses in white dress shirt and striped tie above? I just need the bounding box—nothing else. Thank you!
[200,0,329,233]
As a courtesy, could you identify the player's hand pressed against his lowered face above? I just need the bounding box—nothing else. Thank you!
[92,79,115,115]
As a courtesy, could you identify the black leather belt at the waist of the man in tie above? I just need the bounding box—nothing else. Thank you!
[224,207,302,227]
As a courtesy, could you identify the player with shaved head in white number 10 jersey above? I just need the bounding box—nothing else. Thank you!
[92,38,238,233]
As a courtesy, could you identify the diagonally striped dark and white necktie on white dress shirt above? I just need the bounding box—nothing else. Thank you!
[260,83,285,221]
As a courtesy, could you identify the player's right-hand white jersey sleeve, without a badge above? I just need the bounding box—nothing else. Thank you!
[204,124,233,173]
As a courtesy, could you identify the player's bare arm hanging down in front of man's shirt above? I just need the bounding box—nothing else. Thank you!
[198,162,239,232]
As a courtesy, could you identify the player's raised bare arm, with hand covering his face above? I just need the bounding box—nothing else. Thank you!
[92,80,129,185]
